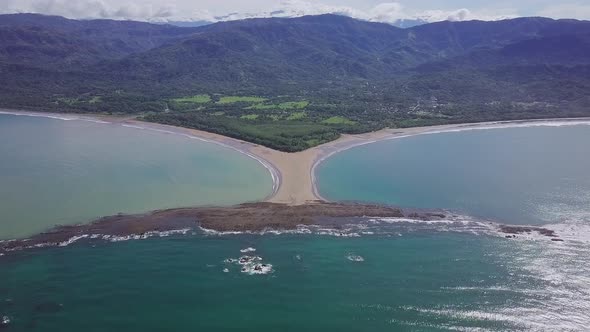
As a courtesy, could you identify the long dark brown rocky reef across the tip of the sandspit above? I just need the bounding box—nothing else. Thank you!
[0,201,445,253]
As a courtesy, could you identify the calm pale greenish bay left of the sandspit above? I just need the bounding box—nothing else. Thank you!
[0,114,272,239]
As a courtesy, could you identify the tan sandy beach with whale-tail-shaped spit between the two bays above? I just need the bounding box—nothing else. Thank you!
[0,108,590,206]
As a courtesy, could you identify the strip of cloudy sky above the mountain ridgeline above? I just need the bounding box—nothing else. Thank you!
[0,0,590,23]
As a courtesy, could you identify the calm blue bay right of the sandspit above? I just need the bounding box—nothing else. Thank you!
[318,125,590,224]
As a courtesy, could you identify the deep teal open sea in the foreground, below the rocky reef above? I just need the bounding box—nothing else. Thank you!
[0,234,588,331]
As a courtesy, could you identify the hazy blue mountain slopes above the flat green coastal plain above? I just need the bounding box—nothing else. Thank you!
[0,14,590,93]
